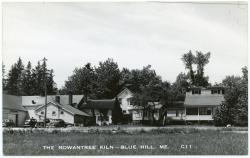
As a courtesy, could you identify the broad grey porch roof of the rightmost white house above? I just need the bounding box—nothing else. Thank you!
[184,95,224,106]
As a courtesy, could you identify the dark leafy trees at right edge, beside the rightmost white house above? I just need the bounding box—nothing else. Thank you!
[214,67,248,126]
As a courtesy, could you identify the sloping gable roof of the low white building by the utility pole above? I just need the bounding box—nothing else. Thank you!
[36,102,90,116]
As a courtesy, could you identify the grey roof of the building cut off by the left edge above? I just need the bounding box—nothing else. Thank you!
[3,94,27,111]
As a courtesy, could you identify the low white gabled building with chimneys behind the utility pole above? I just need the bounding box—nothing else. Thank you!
[20,95,88,123]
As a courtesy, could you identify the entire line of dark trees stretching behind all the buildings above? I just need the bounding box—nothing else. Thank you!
[2,50,248,125]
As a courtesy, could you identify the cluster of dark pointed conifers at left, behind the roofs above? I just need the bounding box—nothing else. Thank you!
[2,57,57,96]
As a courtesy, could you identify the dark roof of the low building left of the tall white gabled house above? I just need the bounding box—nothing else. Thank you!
[79,99,115,109]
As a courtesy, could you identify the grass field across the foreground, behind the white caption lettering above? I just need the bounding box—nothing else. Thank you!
[3,128,248,155]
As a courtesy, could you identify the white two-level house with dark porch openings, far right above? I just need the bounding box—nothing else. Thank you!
[184,87,224,121]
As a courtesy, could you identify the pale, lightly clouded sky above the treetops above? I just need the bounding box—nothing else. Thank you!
[2,2,248,88]
